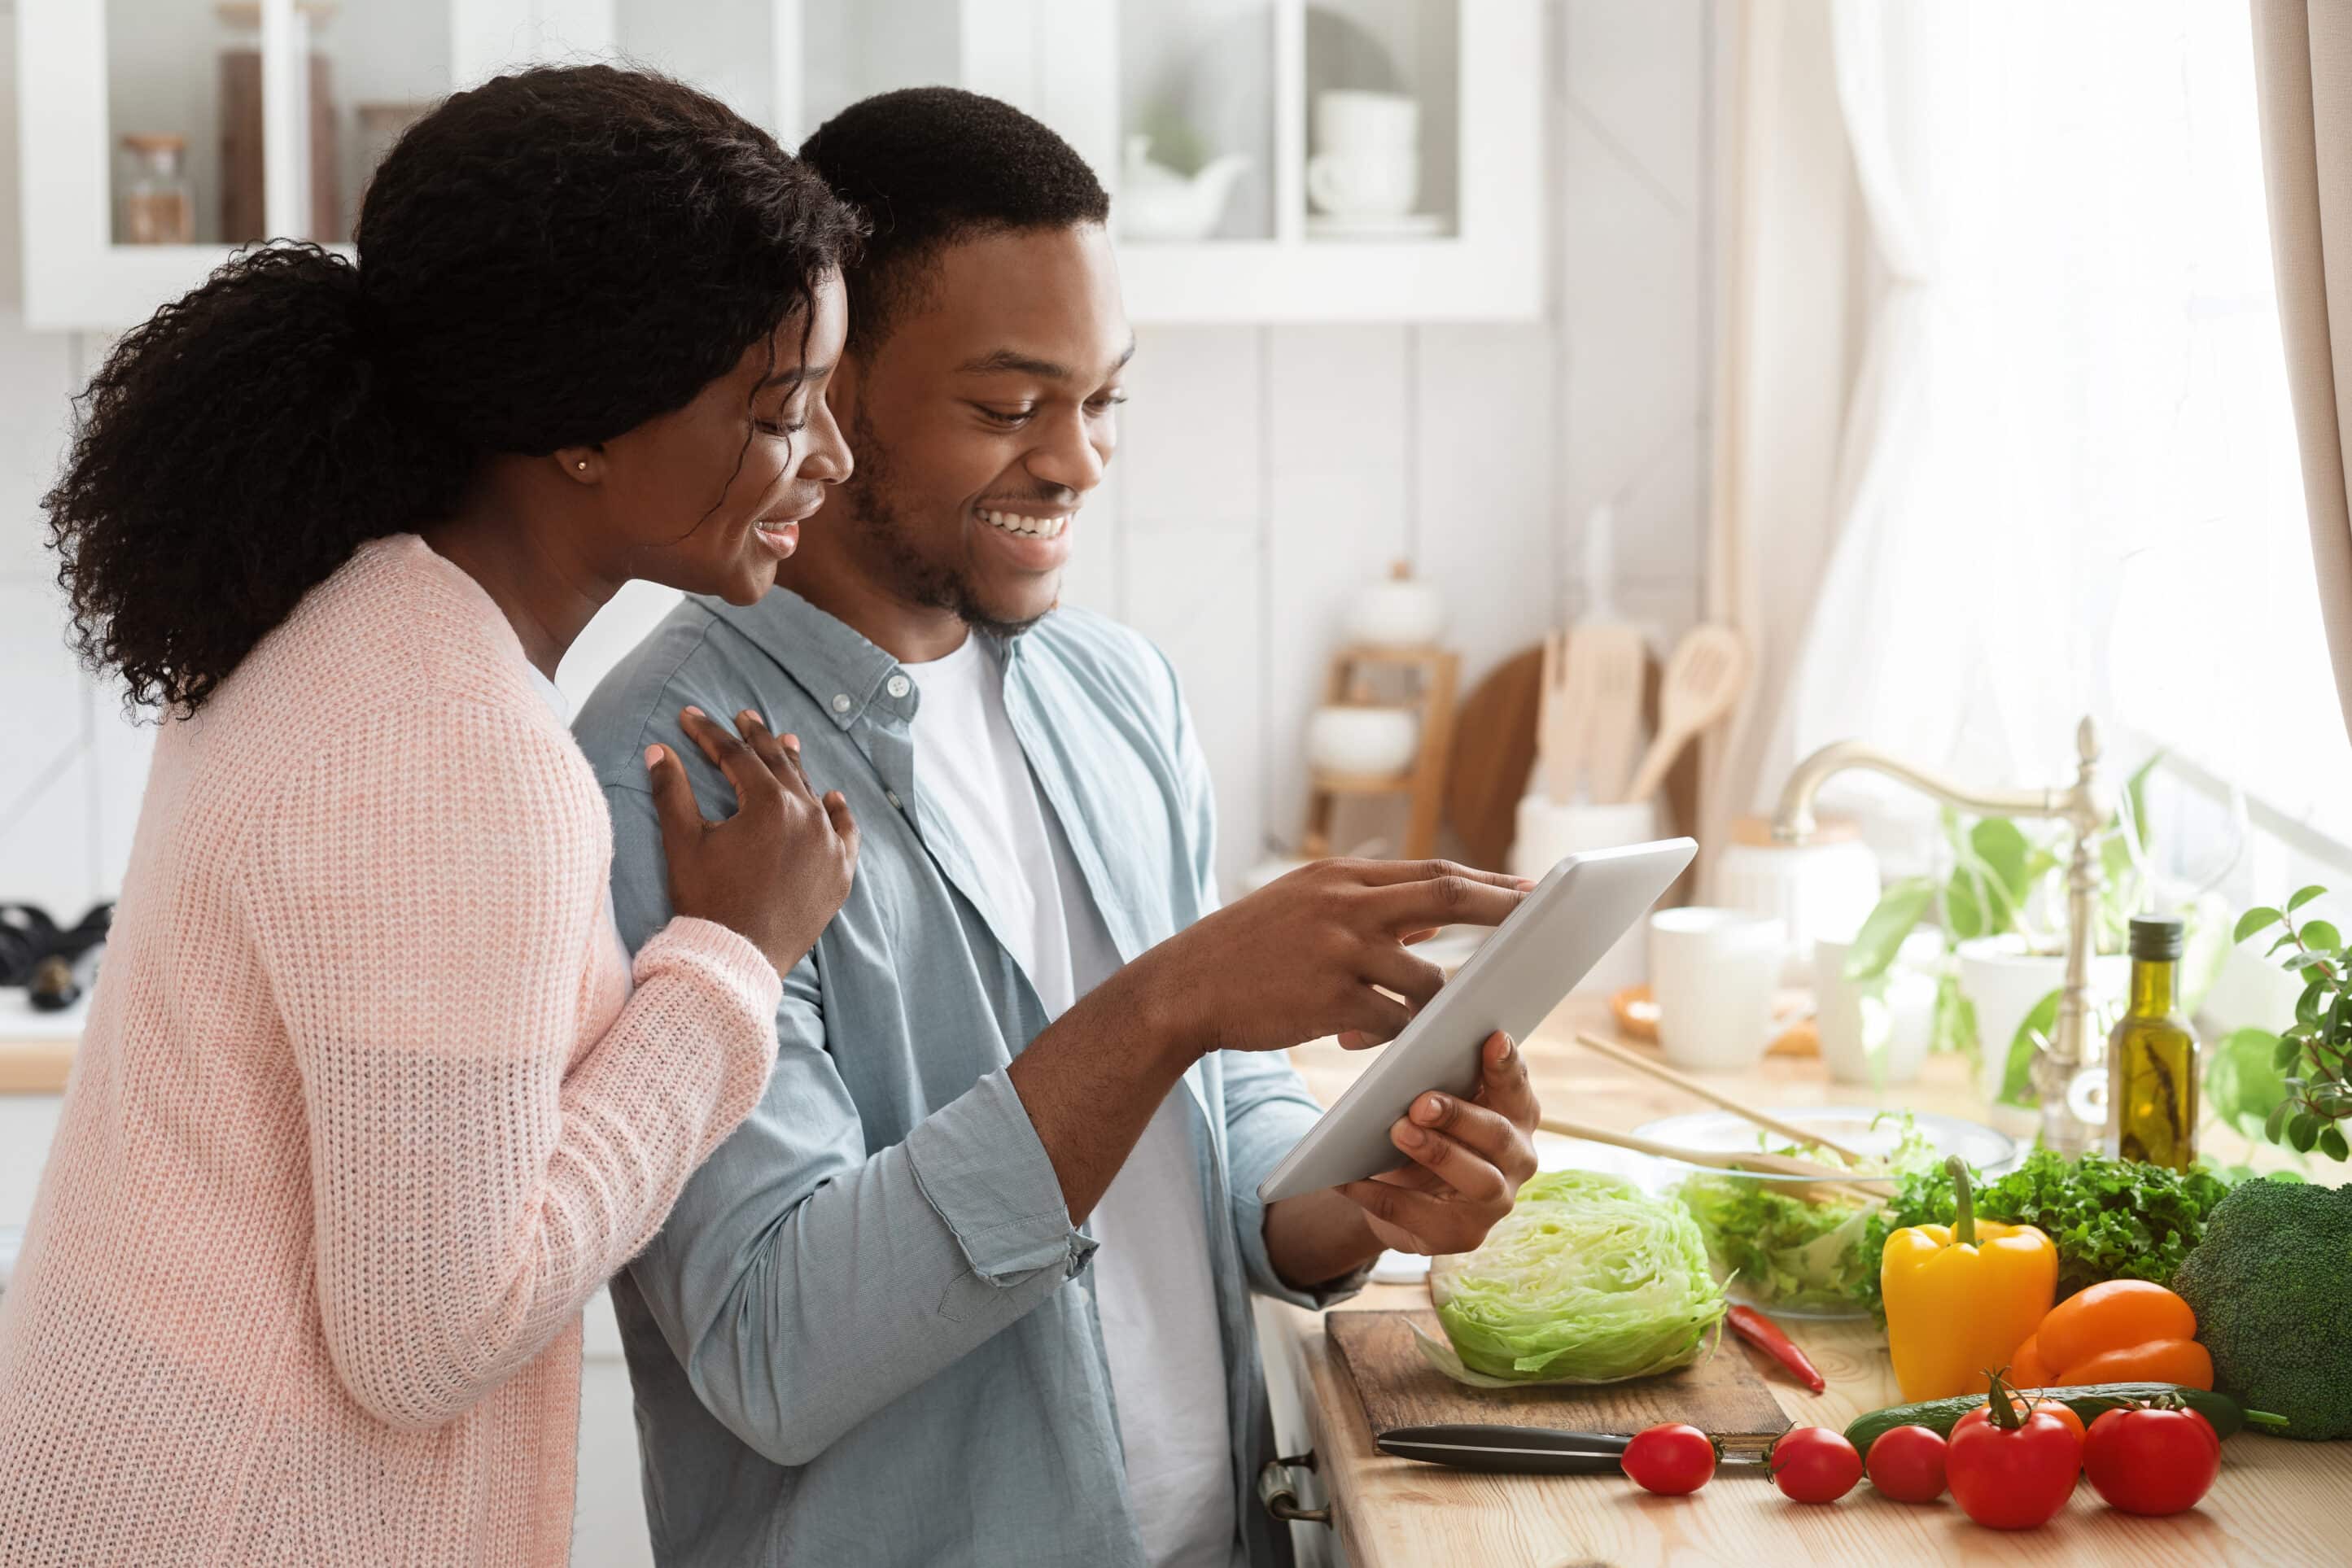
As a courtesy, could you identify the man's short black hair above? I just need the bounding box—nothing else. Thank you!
[800,87,1110,348]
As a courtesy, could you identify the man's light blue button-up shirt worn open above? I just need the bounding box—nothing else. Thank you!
[576,587,1364,1568]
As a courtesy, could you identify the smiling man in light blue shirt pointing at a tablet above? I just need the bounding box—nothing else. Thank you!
[579,90,1536,1568]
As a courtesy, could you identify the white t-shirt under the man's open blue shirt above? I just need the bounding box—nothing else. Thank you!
[908,637,1239,1568]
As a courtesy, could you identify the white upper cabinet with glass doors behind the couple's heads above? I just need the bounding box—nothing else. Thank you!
[32,0,1545,329]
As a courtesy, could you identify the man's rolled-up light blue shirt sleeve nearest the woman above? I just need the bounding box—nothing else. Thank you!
[607,788,1094,1465]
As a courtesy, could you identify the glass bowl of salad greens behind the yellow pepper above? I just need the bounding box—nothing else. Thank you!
[1635,1105,2022,1319]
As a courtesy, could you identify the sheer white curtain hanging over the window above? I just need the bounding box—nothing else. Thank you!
[1757,0,2300,846]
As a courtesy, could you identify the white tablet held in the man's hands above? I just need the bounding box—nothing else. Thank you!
[1258,839,1698,1203]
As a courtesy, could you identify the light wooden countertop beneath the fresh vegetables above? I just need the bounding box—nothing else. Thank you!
[1261,997,2352,1568]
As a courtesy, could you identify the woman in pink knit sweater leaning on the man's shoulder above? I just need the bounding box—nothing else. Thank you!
[0,66,856,1568]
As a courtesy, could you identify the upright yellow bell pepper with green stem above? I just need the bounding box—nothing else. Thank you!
[1879,1155,2058,1404]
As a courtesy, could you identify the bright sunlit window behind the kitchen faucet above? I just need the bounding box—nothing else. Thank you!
[1818,0,2352,867]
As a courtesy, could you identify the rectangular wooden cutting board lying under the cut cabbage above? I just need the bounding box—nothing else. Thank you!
[1324,1312,1790,1452]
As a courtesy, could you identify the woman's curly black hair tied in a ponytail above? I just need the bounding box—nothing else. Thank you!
[42,66,861,714]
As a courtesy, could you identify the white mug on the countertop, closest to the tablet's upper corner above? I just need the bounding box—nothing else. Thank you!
[1649,907,1787,1072]
